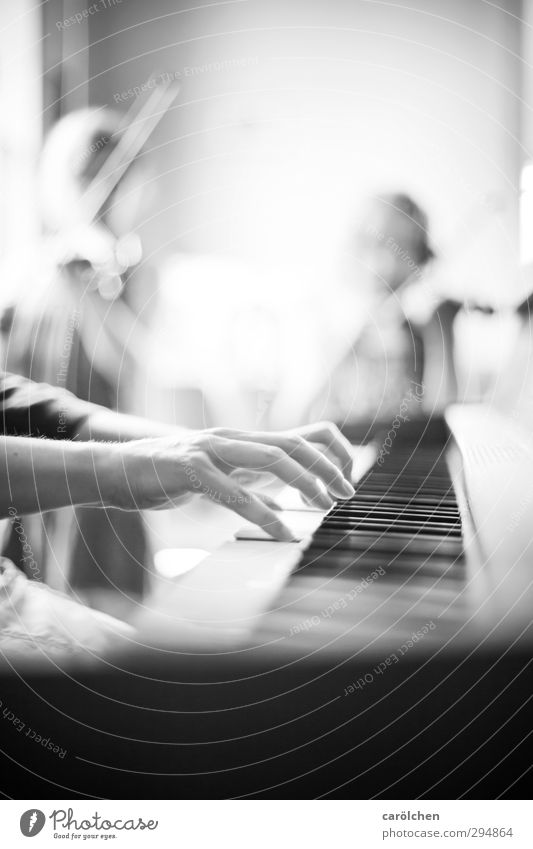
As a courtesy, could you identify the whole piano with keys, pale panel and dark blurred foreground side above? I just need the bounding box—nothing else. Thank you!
[2,405,533,798]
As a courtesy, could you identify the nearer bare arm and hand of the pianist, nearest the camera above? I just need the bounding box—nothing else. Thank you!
[4,426,353,540]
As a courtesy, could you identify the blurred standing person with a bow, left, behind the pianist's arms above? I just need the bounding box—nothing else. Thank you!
[3,109,156,613]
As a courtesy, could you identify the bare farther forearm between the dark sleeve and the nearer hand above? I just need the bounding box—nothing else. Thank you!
[76,404,190,442]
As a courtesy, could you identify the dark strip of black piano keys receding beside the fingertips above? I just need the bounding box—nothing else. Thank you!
[258,424,465,652]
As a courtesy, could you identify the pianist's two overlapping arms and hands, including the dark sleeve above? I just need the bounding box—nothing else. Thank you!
[0,376,354,540]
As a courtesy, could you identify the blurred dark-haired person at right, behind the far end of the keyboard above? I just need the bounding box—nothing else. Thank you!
[309,193,459,441]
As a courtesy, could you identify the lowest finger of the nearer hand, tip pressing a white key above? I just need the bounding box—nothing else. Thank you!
[198,460,295,542]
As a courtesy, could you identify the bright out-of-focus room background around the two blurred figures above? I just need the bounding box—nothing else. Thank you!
[0,0,533,427]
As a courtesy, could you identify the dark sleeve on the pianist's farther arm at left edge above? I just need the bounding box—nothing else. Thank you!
[0,372,93,439]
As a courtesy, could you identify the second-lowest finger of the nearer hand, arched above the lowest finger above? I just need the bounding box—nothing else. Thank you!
[210,439,333,510]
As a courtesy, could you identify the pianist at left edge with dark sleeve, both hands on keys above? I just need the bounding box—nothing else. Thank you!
[0,372,354,661]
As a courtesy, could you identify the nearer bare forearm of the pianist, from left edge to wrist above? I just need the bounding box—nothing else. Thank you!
[0,436,113,517]
